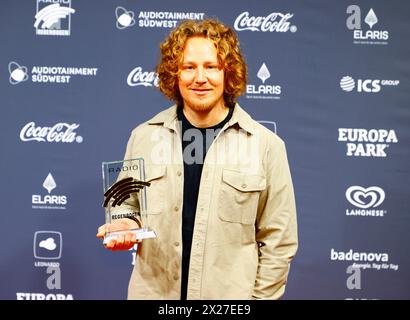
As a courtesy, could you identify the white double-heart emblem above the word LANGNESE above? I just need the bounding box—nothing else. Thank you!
[346,186,386,209]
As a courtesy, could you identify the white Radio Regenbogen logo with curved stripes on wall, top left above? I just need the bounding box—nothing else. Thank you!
[34,0,75,36]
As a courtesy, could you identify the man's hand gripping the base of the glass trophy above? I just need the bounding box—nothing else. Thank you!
[97,218,140,251]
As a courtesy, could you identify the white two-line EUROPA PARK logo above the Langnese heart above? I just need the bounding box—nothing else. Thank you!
[337,128,398,158]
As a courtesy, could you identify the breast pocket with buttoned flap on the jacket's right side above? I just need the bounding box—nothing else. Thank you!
[218,169,266,224]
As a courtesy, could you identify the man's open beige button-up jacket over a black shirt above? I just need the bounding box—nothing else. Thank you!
[115,104,298,299]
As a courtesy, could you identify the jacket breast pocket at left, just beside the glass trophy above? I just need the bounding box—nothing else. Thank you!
[145,165,167,215]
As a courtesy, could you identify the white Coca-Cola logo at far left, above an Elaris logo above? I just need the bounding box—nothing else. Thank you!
[20,122,83,143]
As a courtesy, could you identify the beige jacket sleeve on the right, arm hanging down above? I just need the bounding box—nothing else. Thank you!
[252,137,298,299]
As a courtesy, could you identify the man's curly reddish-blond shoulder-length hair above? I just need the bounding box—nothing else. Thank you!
[156,19,248,106]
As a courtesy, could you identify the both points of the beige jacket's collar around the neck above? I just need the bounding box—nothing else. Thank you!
[148,103,255,134]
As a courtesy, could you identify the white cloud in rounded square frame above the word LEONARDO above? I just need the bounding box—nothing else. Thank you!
[33,231,63,260]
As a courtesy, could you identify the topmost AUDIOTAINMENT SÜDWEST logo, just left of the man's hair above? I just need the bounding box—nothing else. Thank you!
[115,7,205,30]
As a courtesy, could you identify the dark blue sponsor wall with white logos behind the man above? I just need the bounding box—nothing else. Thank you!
[0,0,410,300]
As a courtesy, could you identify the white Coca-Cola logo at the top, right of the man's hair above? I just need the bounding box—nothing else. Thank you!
[234,11,298,32]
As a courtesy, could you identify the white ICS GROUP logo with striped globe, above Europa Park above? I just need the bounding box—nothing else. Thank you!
[339,76,400,93]
